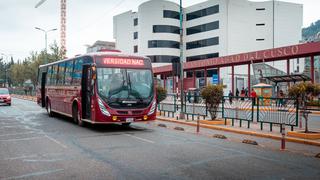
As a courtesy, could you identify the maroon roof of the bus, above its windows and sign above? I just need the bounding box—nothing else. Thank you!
[39,51,149,68]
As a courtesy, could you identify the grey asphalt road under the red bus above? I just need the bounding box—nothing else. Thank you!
[0,99,320,180]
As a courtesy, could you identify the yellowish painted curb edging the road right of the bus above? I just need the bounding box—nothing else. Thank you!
[157,117,320,146]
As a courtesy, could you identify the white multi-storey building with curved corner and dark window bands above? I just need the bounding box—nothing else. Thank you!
[113,0,304,92]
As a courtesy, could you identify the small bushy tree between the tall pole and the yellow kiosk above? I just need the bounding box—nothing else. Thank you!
[201,85,223,120]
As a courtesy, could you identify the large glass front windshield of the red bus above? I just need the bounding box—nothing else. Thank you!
[97,68,153,107]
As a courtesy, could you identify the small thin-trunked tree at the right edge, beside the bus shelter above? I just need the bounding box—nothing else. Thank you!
[289,82,320,133]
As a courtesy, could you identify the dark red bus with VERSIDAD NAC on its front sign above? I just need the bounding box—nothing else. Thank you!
[37,52,156,126]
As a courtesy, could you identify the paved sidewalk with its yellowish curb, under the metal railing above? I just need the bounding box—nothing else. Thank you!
[157,116,320,146]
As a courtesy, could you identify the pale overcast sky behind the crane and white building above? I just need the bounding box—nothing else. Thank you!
[0,0,320,61]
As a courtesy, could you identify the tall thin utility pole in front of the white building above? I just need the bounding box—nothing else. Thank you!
[180,0,184,119]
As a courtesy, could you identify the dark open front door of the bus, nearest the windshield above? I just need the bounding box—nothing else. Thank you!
[81,65,93,119]
